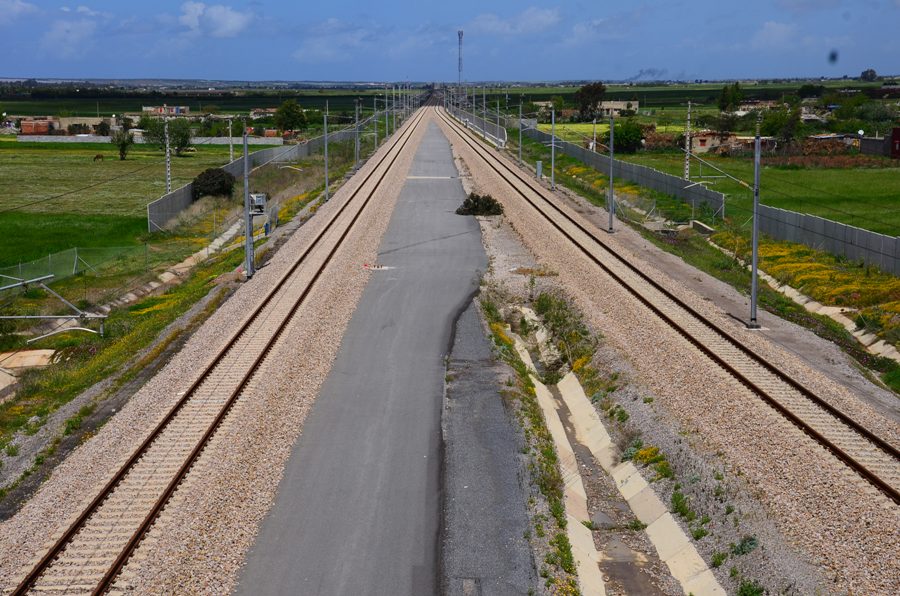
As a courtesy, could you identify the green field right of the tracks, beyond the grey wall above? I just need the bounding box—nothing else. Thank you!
[619,153,900,236]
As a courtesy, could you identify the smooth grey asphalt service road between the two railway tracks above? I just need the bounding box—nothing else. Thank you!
[237,122,487,595]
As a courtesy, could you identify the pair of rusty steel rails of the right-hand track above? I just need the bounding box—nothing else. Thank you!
[439,106,900,504]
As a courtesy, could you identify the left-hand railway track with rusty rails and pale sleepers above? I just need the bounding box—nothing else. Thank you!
[12,110,425,595]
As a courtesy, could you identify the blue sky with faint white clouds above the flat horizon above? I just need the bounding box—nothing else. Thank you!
[0,0,900,81]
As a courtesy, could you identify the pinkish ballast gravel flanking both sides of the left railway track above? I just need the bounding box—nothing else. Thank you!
[0,110,427,594]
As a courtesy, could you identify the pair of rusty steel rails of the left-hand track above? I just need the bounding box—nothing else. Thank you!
[13,110,424,595]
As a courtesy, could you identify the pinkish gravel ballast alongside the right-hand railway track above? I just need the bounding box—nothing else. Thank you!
[441,116,900,593]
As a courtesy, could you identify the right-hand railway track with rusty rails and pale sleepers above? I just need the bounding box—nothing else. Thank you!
[437,110,900,504]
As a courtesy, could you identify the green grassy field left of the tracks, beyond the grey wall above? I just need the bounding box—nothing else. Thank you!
[0,143,263,267]
